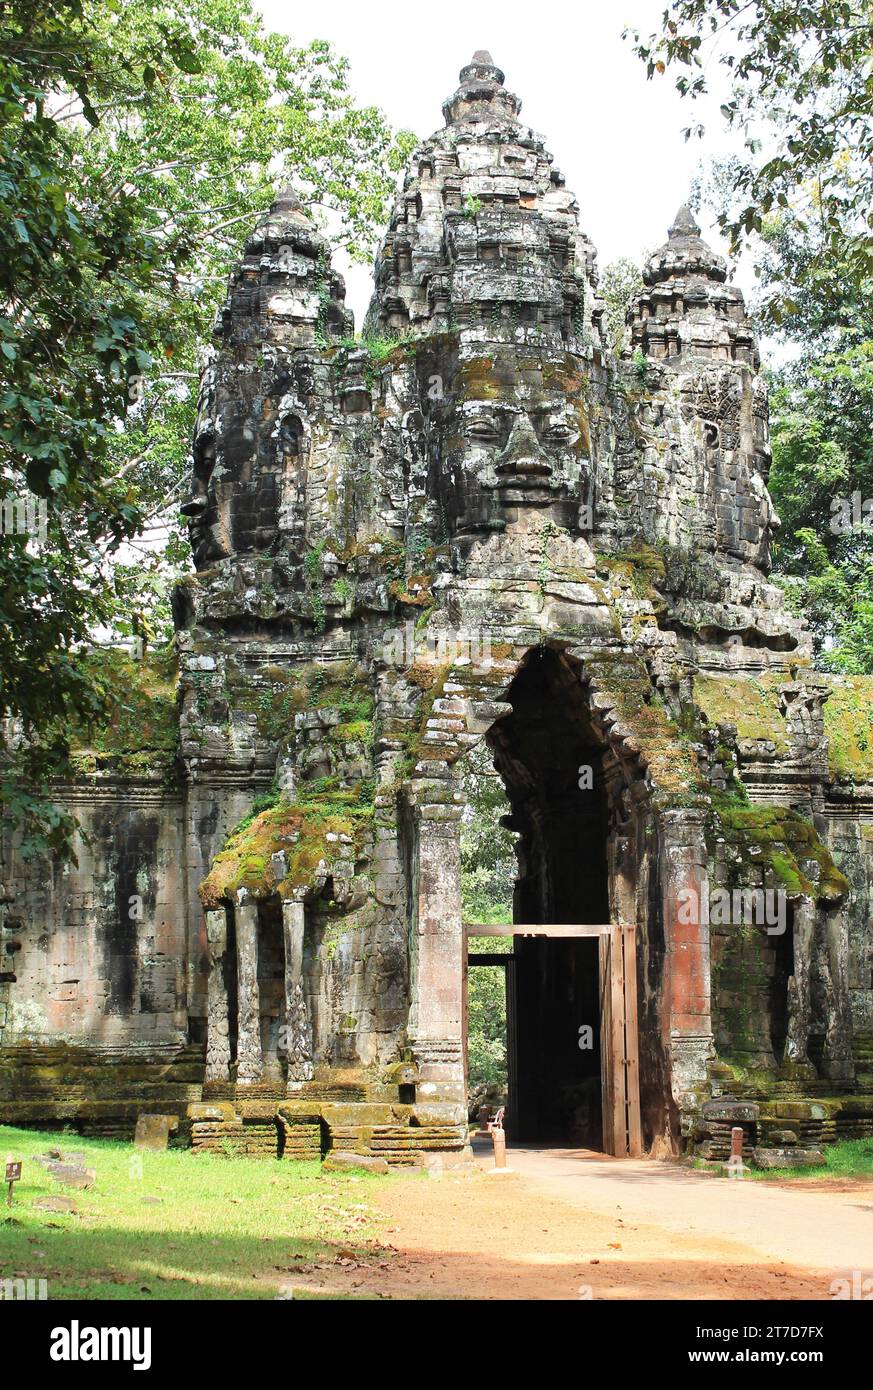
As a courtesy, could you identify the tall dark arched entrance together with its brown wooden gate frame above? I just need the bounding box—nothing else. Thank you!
[464,648,641,1154]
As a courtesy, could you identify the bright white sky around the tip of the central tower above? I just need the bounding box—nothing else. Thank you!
[259,0,749,329]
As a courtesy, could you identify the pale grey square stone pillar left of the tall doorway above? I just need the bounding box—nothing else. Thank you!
[410,802,467,1125]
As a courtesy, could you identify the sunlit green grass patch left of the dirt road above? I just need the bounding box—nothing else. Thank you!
[0,1126,384,1300]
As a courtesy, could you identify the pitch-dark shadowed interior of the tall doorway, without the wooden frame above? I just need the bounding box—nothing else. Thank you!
[469,648,610,1150]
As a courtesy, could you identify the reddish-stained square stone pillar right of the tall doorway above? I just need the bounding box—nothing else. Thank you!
[662,810,713,1109]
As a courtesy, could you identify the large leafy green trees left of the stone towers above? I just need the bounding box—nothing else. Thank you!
[0,0,410,849]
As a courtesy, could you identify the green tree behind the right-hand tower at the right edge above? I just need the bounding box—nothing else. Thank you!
[759,202,873,673]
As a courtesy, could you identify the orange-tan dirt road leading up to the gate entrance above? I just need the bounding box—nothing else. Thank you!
[298,1150,873,1300]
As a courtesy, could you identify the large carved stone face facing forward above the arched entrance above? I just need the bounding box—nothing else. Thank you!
[431,349,591,532]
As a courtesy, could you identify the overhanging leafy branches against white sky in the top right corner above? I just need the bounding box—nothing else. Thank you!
[633,0,873,321]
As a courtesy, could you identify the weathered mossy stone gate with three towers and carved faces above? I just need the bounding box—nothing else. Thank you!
[0,54,873,1162]
